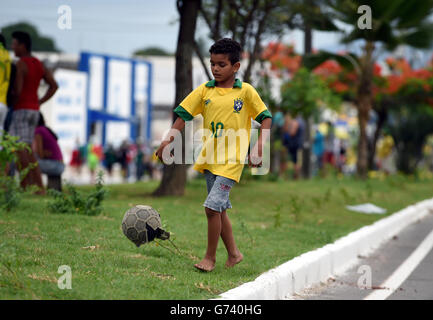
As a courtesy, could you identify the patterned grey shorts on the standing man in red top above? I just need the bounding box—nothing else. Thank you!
[9,109,39,144]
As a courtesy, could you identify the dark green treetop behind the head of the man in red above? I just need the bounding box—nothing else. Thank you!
[1,22,60,52]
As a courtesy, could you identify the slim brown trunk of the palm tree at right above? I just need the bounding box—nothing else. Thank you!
[356,42,374,179]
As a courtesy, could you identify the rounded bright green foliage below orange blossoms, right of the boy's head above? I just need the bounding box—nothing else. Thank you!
[281,68,340,118]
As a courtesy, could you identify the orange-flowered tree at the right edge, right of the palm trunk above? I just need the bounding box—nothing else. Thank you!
[378,58,433,174]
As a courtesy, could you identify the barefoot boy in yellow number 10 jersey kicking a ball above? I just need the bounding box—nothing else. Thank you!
[156,38,272,272]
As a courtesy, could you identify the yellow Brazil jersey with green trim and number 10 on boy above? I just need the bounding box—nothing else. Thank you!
[175,79,272,182]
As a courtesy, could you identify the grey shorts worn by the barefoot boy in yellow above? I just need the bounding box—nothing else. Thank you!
[203,170,236,212]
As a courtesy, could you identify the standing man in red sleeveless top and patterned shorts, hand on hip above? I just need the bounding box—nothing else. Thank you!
[9,31,58,194]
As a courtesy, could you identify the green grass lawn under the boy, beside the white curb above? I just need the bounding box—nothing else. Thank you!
[0,172,433,299]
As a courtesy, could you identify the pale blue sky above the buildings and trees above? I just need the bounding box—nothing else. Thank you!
[0,0,342,57]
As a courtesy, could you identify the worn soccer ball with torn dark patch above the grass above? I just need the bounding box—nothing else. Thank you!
[122,205,170,247]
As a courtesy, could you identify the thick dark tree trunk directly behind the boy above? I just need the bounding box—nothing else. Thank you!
[153,0,201,196]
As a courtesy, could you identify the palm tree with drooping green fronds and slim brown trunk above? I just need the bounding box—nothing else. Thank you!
[304,0,433,178]
